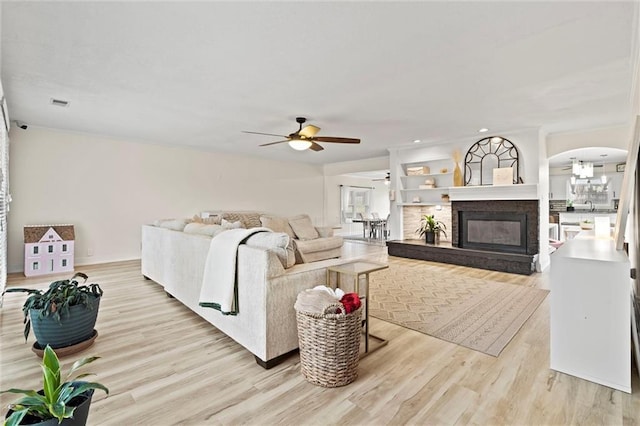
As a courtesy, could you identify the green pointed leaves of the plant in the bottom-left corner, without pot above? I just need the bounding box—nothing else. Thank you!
[0,345,109,426]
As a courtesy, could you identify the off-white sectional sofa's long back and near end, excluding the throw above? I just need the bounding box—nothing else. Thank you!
[142,215,353,368]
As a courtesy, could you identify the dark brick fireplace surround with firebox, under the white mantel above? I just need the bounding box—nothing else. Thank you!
[451,200,539,255]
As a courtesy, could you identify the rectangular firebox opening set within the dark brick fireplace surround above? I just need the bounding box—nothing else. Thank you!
[458,211,527,254]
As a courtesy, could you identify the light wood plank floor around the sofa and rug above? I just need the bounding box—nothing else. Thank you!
[0,245,640,425]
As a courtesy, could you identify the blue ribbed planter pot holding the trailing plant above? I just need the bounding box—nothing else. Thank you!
[29,297,100,349]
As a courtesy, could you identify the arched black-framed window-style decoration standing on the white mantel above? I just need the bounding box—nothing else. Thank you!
[464,136,520,185]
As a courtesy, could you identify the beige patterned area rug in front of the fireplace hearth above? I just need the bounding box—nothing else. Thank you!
[369,257,548,356]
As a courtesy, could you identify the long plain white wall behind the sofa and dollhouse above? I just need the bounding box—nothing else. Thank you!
[8,126,324,272]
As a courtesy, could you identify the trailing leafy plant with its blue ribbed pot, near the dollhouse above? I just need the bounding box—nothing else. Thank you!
[5,272,102,349]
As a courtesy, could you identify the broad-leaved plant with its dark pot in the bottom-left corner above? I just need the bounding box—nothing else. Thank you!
[1,346,109,426]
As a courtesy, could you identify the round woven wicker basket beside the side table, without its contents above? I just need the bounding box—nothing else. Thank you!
[296,305,362,388]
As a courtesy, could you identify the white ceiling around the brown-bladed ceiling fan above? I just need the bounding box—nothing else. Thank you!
[0,1,637,164]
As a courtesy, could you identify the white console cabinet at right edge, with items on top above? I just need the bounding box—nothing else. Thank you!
[551,231,631,393]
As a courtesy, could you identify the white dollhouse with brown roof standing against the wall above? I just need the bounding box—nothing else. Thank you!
[24,225,75,277]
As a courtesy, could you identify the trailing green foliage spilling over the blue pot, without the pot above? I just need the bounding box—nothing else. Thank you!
[4,272,102,340]
